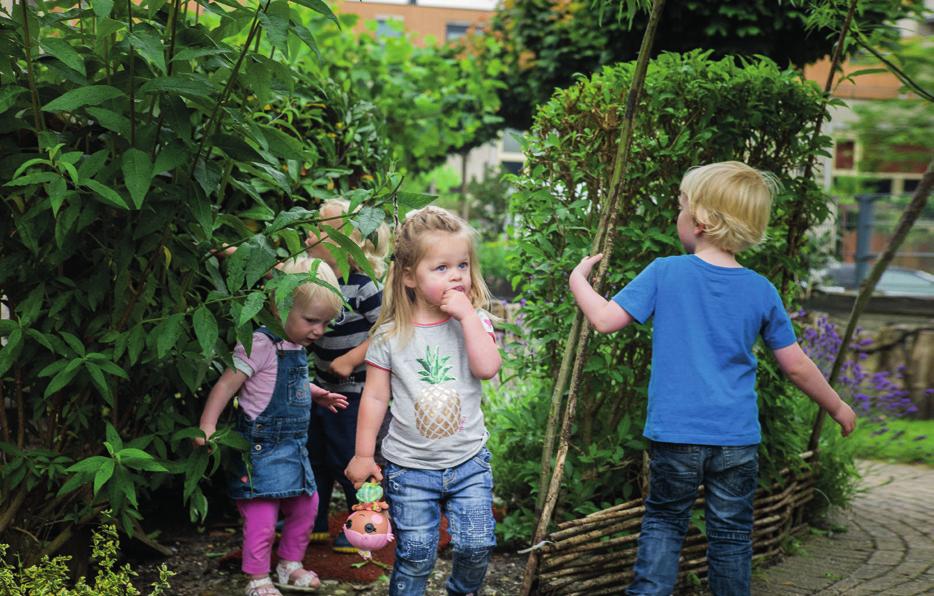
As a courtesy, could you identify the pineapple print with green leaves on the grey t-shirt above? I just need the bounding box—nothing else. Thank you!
[415,347,461,440]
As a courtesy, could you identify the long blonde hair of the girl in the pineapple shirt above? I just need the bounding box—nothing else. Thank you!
[371,205,490,344]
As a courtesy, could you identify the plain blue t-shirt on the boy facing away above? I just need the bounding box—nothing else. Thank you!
[613,255,796,445]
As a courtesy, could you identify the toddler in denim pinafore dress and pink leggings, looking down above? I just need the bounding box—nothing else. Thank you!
[196,258,346,596]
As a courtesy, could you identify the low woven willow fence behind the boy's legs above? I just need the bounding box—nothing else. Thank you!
[538,451,814,596]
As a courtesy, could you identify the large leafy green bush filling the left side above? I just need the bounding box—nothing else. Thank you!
[0,0,495,561]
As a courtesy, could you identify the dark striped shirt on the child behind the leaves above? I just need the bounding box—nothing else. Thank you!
[311,272,383,395]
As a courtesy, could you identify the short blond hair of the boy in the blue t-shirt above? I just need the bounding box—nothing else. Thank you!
[681,161,779,254]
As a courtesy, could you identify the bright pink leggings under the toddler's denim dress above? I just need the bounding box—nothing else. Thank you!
[237,492,318,575]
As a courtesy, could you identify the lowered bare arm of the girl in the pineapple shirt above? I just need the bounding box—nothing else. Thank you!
[344,365,390,487]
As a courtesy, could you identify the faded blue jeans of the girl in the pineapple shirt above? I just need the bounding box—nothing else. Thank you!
[384,447,496,596]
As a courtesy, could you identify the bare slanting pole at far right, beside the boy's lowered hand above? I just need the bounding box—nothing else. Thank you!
[808,160,934,451]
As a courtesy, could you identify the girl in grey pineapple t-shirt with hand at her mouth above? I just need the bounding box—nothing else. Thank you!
[345,207,501,596]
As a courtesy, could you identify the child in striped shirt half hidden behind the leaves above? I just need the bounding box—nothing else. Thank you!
[306,199,389,554]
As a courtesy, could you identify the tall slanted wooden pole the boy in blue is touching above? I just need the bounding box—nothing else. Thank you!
[521,0,665,596]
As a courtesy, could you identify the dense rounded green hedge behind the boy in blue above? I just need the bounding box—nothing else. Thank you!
[488,52,829,535]
